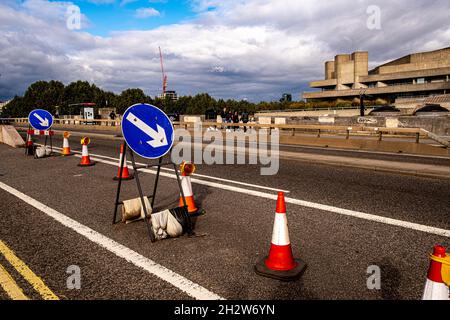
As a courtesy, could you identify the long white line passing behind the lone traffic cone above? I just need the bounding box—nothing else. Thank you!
[44,145,450,238]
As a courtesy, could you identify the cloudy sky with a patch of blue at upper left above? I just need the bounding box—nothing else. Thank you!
[0,0,450,101]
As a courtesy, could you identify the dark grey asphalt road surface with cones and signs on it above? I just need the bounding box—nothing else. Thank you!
[0,135,450,300]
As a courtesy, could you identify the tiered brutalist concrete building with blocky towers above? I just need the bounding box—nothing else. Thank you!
[303,47,450,103]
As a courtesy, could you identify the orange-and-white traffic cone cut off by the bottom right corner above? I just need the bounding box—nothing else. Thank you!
[422,245,450,300]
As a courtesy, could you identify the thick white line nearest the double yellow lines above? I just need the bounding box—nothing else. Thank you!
[0,182,224,300]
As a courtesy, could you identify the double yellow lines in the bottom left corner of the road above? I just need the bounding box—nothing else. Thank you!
[0,240,59,300]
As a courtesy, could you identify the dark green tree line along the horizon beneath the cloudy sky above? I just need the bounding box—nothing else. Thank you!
[3,81,313,117]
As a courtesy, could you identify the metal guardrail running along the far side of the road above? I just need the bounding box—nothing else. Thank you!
[0,118,449,148]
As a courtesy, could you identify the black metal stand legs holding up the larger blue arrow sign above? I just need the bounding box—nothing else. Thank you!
[113,141,195,242]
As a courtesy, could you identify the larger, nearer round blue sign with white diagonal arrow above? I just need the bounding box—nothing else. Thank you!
[122,103,174,159]
